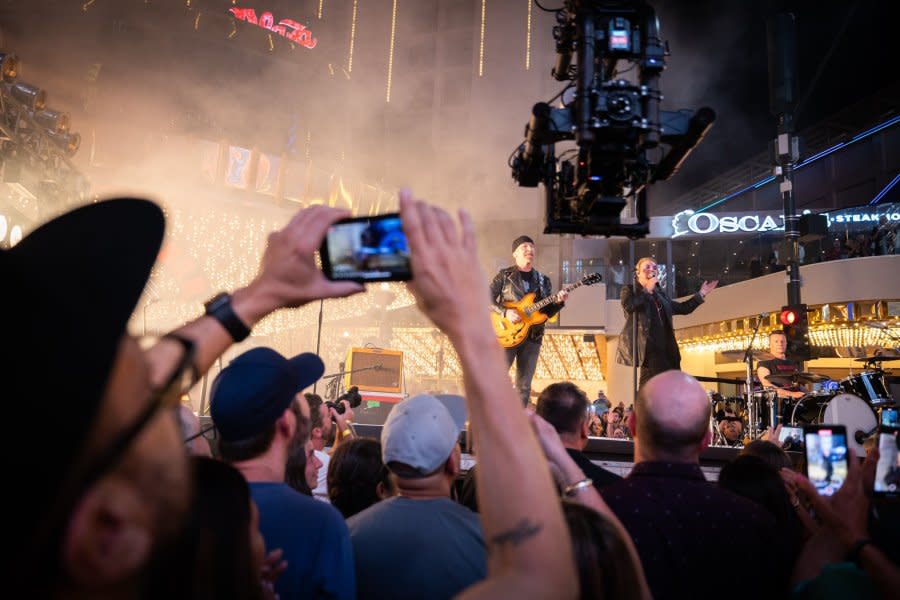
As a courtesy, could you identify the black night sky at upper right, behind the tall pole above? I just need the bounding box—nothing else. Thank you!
[654,0,900,209]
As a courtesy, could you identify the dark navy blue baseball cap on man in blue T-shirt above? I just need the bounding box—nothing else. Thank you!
[210,348,325,442]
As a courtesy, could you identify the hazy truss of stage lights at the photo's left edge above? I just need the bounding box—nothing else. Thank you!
[0,53,86,202]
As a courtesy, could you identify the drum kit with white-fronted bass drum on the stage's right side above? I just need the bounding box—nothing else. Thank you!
[712,356,900,455]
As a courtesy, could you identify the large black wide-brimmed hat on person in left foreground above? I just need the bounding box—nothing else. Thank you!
[0,198,165,535]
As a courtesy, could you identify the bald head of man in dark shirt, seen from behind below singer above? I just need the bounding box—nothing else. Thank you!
[635,371,710,460]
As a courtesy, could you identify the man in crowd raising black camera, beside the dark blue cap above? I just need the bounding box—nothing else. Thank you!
[305,386,362,502]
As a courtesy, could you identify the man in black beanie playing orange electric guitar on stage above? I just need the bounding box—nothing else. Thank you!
[491,235,569,406]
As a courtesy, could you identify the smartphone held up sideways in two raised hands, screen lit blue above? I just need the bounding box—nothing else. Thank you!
[319,213,412,282]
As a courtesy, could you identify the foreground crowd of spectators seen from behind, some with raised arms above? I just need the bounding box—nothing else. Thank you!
[0,191,900,600]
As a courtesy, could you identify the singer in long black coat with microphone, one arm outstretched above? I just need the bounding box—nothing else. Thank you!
[616,257,719,386]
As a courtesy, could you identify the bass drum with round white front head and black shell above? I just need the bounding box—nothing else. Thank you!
[791,394,878,457]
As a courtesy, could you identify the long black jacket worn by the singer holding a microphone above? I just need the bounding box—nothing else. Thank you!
[616,283,703,367]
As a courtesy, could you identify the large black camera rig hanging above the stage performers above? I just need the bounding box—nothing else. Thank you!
[510,0,715,238]
